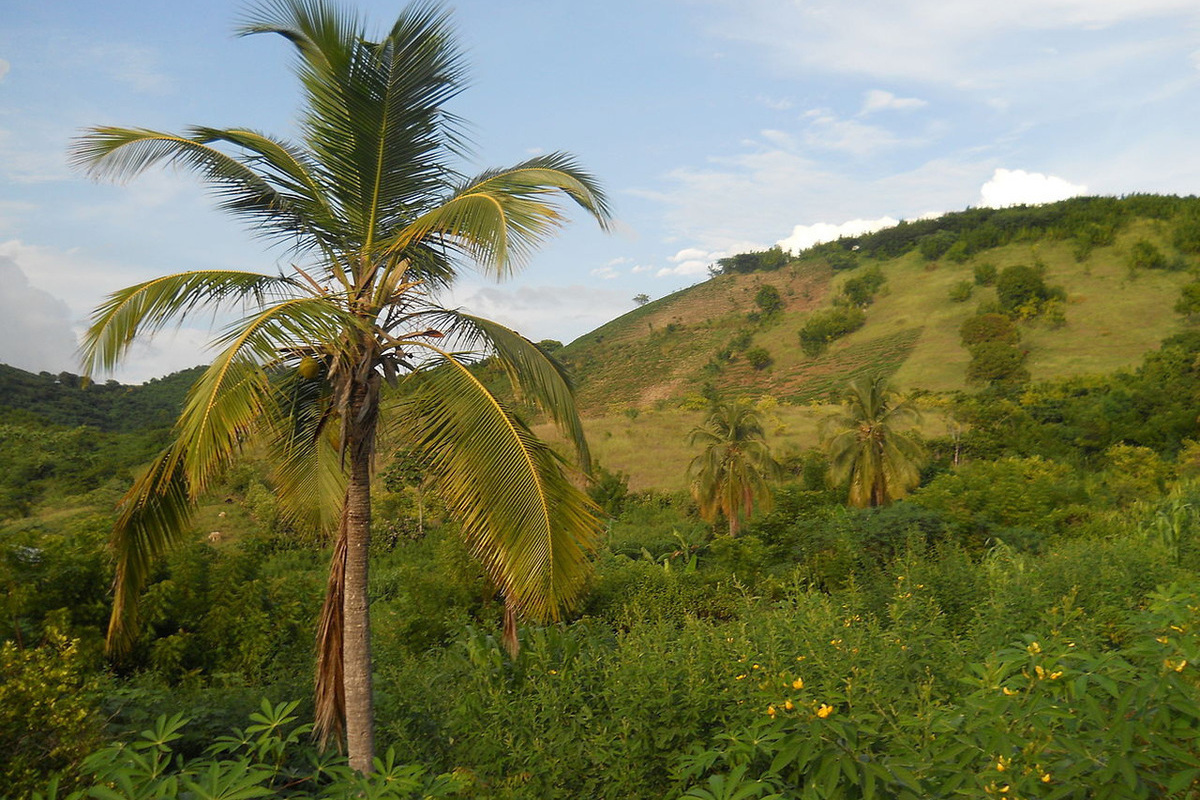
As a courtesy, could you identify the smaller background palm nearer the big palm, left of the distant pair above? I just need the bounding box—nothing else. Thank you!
[688,401,779,536]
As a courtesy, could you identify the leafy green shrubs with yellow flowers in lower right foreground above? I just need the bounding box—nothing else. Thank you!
[680,587,1200,800]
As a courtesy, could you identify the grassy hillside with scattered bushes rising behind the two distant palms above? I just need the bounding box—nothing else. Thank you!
[557,196,1200,416]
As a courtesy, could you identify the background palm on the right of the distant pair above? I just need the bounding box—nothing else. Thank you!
[822,378,925,509]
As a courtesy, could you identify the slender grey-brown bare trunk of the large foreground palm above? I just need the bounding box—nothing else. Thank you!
[342,386,376,774]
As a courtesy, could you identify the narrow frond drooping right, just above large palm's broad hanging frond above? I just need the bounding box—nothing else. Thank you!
[433,309,592,469]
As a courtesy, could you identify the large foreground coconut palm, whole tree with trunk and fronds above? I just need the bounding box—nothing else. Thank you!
[73,0,611,771]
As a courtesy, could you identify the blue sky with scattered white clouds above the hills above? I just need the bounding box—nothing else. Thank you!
[0,0,1200,380]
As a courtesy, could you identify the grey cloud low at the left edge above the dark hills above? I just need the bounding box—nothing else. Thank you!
[0,255,78,372]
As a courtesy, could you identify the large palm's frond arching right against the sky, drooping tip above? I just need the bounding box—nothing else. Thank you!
[384,154,612,277]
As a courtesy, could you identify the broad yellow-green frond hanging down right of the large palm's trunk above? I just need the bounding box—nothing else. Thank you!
[392,354,602,619]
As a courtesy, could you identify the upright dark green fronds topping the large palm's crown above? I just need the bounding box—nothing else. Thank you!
[244,0,462,251]
